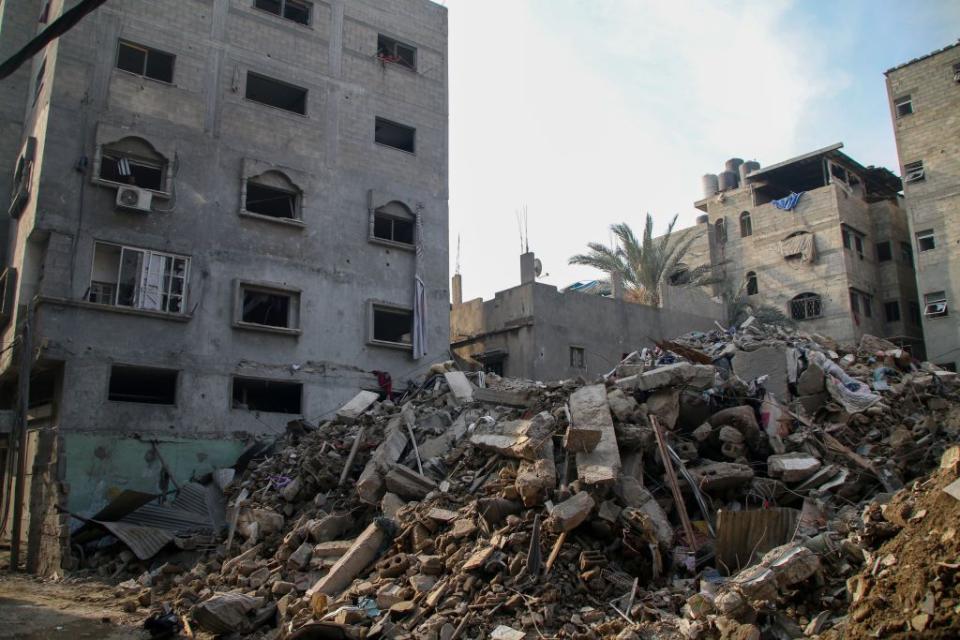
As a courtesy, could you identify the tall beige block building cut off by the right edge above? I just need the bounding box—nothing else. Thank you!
[886,41,960,371]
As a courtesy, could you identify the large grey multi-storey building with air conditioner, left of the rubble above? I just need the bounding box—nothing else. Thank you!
[0,0,449,569]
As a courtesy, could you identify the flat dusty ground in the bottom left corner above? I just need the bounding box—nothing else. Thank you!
[0,563,148,640]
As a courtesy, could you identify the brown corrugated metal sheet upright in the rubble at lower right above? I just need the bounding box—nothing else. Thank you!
[716,508,800,574]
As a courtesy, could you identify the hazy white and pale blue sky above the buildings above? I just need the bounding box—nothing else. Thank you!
[443,0,960,299]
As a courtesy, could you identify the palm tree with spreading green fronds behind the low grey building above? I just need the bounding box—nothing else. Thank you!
[568,213,718,306]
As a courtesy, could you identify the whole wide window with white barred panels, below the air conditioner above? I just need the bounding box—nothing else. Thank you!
[87,242,190,313]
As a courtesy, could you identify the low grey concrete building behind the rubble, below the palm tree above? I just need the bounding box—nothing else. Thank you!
[450,252,725,380]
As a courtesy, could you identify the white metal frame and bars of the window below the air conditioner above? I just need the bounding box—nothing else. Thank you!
[84,240,191,316]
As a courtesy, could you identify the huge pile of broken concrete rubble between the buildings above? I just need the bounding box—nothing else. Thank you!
[86,320,960,640]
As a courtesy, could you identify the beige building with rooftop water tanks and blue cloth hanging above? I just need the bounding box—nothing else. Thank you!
[687,144,923,356]
